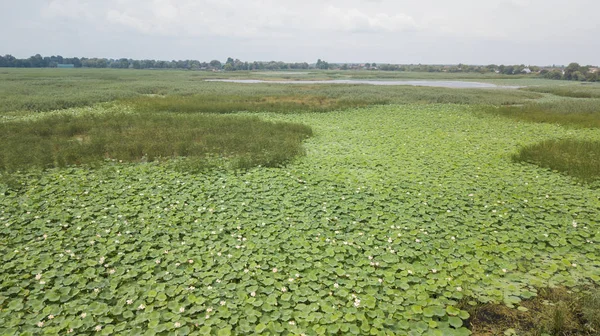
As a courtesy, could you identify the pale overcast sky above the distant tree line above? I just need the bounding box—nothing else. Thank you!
[0,0,600,65]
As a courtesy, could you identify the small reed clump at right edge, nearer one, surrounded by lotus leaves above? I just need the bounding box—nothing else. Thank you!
[513,139,600,182]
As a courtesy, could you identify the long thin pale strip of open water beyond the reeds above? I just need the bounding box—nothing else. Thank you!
[206,79,520,89]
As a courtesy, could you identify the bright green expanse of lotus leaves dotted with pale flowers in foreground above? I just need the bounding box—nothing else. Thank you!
[0,104,600,335]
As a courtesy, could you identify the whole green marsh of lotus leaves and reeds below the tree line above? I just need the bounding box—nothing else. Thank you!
[0,70,600,336]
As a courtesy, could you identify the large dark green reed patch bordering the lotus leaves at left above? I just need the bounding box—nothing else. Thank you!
[0,113,312,171]
